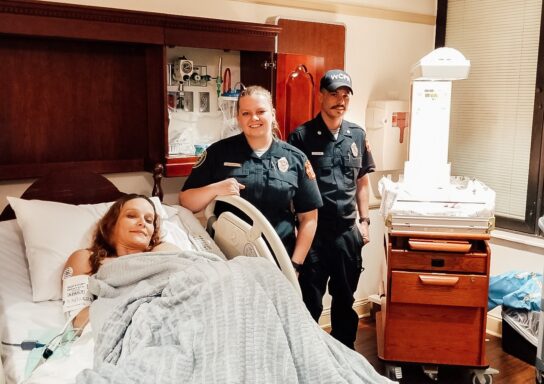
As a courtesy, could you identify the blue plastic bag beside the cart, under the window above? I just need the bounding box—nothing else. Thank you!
[487,271,542,311]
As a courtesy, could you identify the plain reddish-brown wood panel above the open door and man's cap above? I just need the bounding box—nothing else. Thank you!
[278,18,346,70]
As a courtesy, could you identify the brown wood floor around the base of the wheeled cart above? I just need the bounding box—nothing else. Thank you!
[355,318,535,384]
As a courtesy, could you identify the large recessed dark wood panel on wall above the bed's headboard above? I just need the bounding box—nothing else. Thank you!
[0,36,147,177]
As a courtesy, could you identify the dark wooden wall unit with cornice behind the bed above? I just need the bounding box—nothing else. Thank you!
[0,0,281,180]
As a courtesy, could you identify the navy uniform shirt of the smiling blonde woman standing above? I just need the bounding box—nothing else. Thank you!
[182,134,323,253]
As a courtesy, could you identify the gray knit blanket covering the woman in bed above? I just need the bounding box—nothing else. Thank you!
[77,251,392,384]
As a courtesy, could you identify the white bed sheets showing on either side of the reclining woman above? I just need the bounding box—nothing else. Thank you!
[0,205,226,384]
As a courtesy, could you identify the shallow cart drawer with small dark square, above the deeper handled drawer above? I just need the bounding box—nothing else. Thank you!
[388,249,487,274]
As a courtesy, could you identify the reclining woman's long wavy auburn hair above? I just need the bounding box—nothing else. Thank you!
[89,193,161,274]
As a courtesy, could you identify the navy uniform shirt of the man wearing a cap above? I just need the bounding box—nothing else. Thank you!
[288,113,376,226]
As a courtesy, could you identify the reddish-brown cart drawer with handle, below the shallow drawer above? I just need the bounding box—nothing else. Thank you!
[390,271,489,307]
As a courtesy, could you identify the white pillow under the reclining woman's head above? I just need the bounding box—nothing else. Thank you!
[7,196,167,301]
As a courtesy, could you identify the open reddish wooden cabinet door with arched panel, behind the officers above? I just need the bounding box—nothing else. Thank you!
[275,53,324,140]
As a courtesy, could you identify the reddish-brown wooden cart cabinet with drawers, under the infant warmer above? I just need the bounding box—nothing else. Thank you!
[376,233,490,367]
